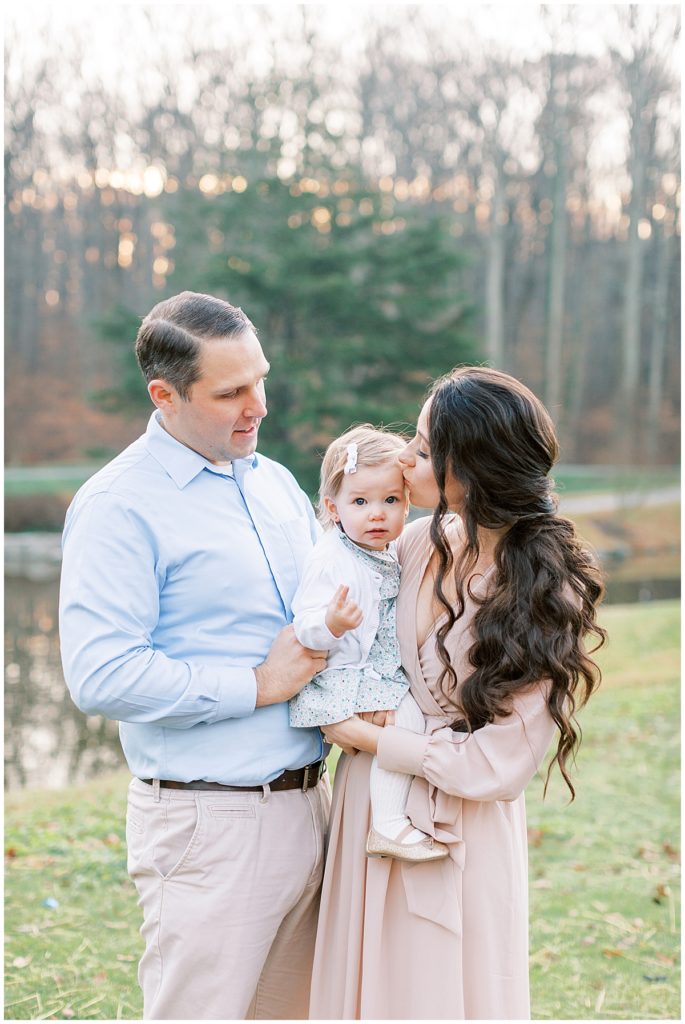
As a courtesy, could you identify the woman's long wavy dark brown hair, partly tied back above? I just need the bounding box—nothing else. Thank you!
[429,367,606,800]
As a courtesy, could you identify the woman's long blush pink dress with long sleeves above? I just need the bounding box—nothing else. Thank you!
[309,518,555,1020]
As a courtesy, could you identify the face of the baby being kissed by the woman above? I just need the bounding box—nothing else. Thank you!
[326,463,409,551]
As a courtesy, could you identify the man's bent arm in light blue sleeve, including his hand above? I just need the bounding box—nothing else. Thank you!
[59,494,323,729]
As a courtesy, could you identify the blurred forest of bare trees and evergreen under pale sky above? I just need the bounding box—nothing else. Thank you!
[5,4,681,516]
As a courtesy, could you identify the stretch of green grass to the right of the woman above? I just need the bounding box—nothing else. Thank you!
[527,601,680,1020]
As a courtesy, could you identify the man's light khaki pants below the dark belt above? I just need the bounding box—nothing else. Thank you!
[126,775,331,1020]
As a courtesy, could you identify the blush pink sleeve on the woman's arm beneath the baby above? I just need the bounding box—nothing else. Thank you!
[378,683,556,801]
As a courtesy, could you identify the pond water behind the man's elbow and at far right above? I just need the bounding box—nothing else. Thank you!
[5,552,680,790]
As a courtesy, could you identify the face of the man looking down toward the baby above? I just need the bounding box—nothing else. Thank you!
[151,330,269,463]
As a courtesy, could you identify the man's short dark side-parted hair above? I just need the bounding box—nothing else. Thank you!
[135,292,256,400]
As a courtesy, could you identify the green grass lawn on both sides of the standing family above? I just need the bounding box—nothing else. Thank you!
[5,601,680,1020]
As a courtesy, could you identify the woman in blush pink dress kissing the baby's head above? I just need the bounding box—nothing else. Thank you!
[310,367,603,1020]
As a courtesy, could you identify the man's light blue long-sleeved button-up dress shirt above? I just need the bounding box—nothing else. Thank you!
[59,412,324,785]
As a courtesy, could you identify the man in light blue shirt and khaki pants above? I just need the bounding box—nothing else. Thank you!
[60,292,330,1020]
